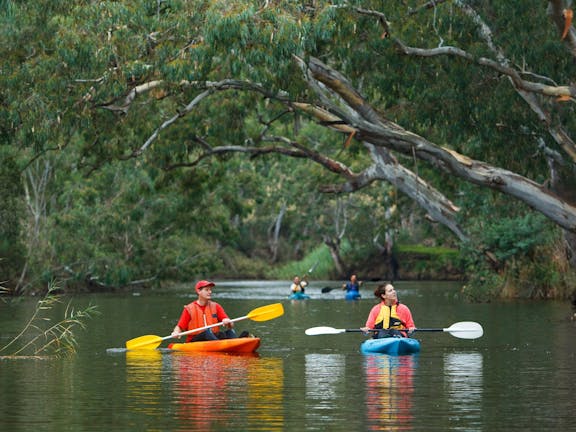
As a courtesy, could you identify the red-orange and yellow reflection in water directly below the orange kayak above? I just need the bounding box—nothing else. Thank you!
[172,353,284,431]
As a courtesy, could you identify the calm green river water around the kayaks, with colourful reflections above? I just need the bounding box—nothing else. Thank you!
[0,282,576,432]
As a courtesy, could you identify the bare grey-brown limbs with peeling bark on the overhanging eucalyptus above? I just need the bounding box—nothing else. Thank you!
[133,5,576,255]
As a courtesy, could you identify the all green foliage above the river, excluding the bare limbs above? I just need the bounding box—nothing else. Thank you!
[0,0,576,296]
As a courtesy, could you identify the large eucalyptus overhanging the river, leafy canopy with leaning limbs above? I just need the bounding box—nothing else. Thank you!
[1,0,576,296]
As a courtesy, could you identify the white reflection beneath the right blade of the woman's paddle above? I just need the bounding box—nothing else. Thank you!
[444,352,484,430]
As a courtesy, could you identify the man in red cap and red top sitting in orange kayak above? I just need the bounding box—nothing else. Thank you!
[172,280,237,342]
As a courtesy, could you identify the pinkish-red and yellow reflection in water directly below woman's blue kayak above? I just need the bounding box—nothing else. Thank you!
[364,355,418,431]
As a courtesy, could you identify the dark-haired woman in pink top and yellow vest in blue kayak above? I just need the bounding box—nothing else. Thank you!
[362,284,416,338]
